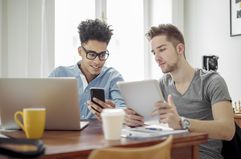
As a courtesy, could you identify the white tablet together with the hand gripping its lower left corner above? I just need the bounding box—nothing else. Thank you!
[117,80,164,127]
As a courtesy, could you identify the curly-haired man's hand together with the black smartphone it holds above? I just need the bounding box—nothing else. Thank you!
[87,87,115,120]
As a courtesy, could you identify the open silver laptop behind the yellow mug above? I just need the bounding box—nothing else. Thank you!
[0,78,88,130]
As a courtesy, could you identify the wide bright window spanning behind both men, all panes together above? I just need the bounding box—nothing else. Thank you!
[55,0,172,81]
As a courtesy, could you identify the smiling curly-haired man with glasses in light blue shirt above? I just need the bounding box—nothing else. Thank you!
[49,19,125,120]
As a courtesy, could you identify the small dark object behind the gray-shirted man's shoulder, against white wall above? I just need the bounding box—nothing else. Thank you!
[203,55,218,71]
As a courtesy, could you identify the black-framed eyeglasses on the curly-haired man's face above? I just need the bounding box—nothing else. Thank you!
[81,46,109,61]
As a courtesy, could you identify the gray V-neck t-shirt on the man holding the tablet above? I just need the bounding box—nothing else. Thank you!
[160,69,231,159]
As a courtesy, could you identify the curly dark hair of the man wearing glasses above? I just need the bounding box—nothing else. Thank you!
[78,19,113,44]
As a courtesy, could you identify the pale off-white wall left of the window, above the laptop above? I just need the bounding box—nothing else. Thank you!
[1,0,54,77]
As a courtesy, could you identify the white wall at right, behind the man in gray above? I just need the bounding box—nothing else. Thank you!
[184,0,241,101]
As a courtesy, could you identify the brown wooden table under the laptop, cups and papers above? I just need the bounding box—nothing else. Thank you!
[2,121,208,159]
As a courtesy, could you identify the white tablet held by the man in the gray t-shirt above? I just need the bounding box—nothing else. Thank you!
[117,80,164,121]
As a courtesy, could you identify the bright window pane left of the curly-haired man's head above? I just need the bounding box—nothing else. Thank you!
[55,0,95,67]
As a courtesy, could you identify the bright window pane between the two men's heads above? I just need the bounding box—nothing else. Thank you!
[107,0,144,81]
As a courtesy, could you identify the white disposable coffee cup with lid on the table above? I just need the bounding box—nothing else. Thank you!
[101,108,125,140]
